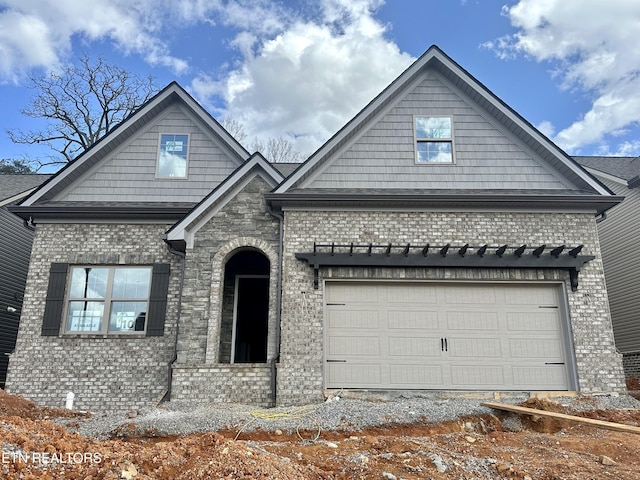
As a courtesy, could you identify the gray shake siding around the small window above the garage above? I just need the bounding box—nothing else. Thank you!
[307,73,568,189]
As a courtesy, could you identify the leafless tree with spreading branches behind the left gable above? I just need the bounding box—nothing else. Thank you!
[7,55,158,168]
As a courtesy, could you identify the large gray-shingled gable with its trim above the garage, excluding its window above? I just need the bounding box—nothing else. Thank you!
[274,46,610,195]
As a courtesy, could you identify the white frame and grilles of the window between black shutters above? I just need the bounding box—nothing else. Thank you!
[61,265,153,336]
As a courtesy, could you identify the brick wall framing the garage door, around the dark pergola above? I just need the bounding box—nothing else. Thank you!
[278,211,624,404]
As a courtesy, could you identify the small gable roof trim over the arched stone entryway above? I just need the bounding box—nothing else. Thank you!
[165,153,284,251]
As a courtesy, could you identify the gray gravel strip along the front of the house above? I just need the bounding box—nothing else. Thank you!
[70,394,640,439]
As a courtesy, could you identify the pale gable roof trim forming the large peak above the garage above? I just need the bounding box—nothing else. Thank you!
[271,46,611,198]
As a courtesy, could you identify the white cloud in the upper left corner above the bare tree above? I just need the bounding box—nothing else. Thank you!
[0,0,205,81]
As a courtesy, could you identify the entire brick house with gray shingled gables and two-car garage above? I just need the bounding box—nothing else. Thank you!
[7,46,624,410]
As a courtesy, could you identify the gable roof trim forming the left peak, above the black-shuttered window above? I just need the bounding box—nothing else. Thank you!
[21,82,249,206]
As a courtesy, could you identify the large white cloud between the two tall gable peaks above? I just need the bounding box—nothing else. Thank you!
[191,0,413,154]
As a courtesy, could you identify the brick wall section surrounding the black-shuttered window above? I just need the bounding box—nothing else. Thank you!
[7,224,180,411]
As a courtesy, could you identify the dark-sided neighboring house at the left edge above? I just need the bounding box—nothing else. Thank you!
[0,174,50,388]
